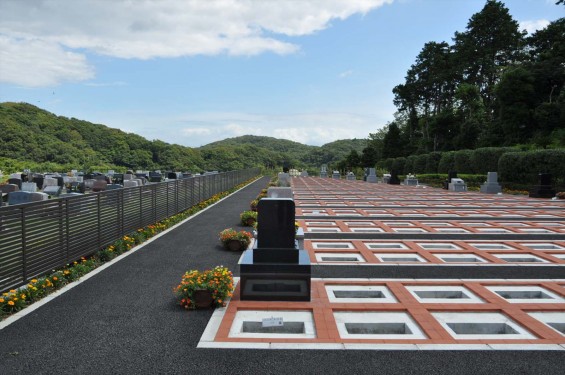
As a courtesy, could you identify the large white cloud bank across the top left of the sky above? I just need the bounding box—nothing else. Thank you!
[0,0,393,86]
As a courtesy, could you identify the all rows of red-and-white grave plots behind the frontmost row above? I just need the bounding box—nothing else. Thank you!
[293,178,565,265]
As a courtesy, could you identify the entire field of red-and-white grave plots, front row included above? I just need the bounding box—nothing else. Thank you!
[205,177,565,350]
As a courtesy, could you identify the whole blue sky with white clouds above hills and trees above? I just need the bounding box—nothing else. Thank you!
[0,0,565,147]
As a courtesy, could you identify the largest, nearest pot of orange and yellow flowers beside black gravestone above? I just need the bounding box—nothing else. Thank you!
[173,266,233,309]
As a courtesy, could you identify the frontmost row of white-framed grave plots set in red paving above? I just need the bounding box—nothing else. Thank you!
[198,278,565,350]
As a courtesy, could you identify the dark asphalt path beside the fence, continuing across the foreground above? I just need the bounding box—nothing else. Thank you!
[0,178,565,375]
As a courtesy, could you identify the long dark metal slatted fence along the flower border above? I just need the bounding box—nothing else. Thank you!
[0,169,260,291]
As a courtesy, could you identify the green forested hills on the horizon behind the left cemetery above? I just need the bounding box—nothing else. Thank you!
[0,102,367,171]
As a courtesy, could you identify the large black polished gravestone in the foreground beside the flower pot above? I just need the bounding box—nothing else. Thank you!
[239,198,311,301]
